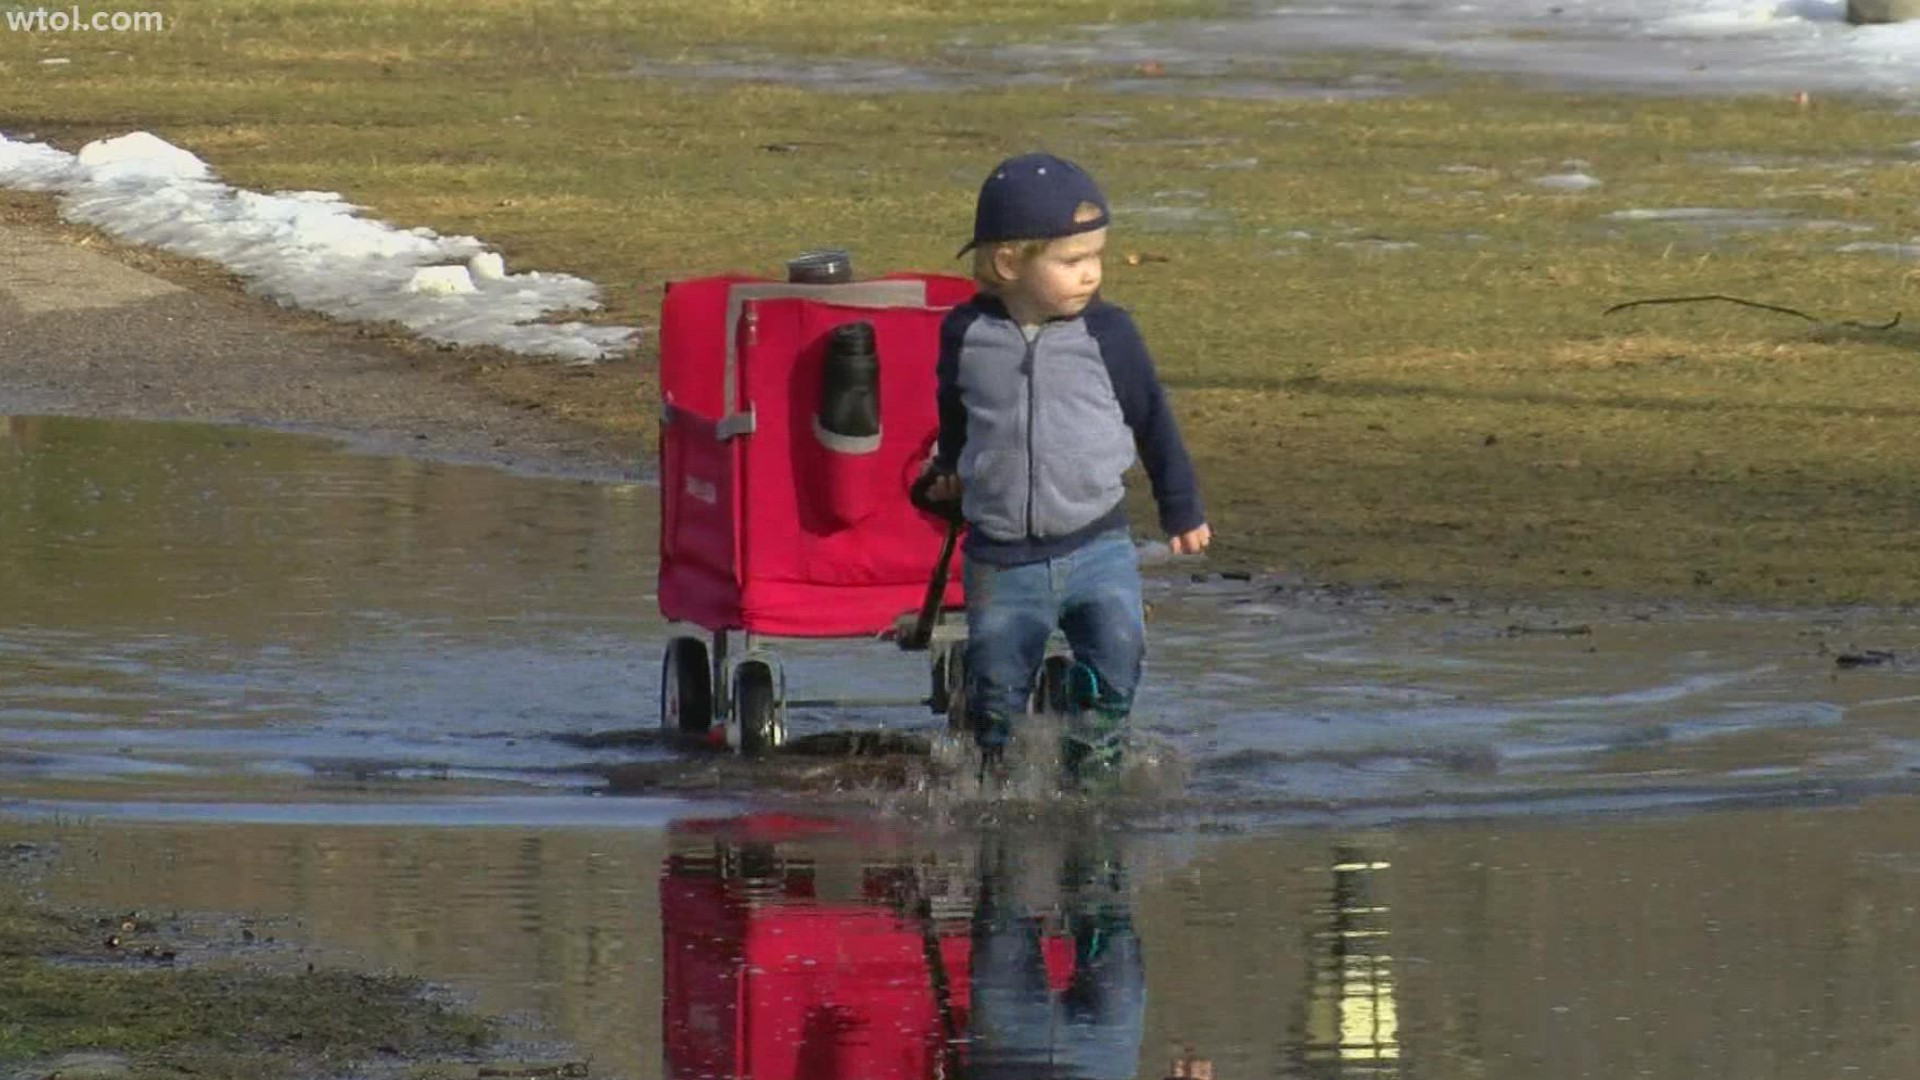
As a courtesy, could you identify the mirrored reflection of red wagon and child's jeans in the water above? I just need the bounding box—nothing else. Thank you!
[660,817,1146,1080]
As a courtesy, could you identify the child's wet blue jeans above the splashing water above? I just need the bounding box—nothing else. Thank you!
[964,528,1146,749]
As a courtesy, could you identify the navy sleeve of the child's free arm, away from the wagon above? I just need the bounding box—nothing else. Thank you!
[1087,304,1206,536]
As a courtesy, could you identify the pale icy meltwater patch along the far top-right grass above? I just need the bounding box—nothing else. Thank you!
[630,0,1920,102]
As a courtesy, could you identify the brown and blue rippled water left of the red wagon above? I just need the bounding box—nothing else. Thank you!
[0,417,659,798]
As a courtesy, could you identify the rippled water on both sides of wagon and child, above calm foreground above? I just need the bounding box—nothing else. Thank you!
[0,409,1920,826]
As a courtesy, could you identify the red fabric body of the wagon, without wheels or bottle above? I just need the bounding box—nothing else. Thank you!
[659,275,975,638]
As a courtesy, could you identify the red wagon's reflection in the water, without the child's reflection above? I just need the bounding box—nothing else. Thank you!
[660,815,1073,1080]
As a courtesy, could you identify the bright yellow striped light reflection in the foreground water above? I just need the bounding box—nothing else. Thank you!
[1300,846,1400,1076]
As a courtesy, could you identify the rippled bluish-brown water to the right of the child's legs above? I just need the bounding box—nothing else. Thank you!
[1150,598,1920,819]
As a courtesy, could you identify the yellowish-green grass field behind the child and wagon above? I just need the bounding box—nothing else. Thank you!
[0,0,1920,603]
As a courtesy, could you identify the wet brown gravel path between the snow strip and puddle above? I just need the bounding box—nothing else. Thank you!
[0,216,643,477]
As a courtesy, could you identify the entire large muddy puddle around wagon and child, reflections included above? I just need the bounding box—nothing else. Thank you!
[0,409,1920,1078]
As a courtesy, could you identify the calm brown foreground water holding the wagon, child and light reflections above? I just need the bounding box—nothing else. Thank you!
[22,799,1920,1080]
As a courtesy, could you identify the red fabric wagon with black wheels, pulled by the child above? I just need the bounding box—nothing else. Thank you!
[659,257,973,753]
